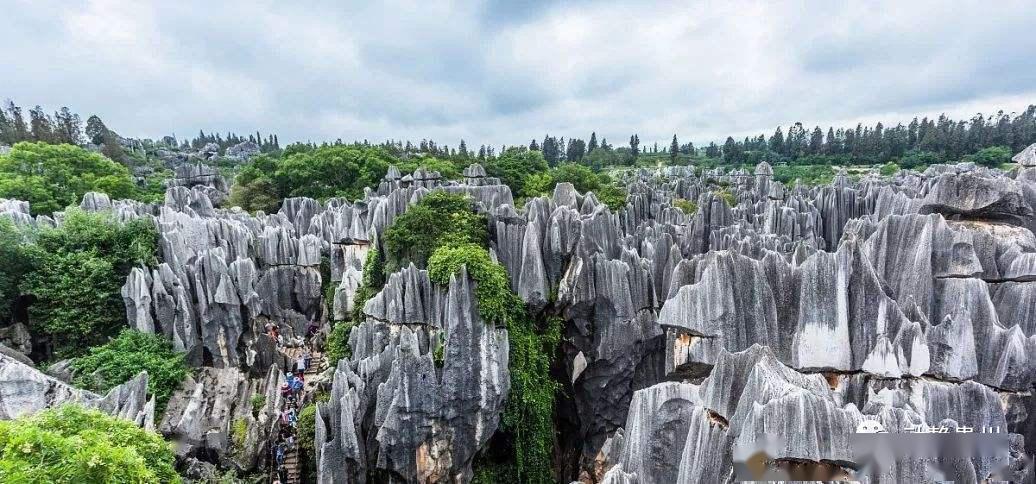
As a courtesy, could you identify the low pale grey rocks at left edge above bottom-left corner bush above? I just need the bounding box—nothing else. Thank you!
[0,351,154,430]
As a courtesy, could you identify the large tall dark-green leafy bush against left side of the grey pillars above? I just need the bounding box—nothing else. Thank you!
[21,209,156,357]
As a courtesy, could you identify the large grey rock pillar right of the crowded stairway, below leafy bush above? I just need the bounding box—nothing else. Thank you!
[316,265,510,483]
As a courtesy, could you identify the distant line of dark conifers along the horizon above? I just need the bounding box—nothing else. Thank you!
[0,96,1036,168]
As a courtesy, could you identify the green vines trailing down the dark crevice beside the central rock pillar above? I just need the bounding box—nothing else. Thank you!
[428,244,560,482]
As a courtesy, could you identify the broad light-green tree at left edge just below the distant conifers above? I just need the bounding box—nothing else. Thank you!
[0,142,137,215]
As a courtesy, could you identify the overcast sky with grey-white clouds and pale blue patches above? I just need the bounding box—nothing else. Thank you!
[0,0,1036,146]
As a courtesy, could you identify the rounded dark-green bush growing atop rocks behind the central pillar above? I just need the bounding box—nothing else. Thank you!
[383,191,488,274]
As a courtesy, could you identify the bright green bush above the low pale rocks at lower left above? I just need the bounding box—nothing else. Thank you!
[73,329,188,412]
